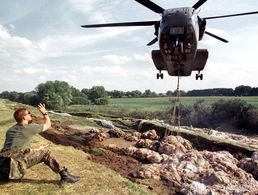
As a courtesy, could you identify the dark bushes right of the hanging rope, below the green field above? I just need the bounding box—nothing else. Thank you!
[168,99,258,133]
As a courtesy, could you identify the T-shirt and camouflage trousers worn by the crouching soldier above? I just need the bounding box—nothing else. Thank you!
[0,124,62,180]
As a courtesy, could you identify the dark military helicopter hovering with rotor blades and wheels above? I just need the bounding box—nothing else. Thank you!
[81,0,258,80]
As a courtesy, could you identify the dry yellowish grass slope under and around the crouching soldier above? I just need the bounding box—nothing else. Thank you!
[0,99,153,195]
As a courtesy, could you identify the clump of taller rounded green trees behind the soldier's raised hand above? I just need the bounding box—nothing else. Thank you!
[0,81,108,109]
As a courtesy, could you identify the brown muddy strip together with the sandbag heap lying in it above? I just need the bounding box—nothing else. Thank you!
[42,117,258,194]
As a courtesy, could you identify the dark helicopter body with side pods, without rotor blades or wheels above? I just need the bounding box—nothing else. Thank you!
[152,7,208,79]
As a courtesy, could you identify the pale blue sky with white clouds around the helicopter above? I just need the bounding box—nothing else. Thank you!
[0,0,258,93]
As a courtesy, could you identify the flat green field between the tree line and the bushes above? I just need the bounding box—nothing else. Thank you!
[66,96,258,116]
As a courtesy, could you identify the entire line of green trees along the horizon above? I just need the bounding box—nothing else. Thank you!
[0,81,258,109]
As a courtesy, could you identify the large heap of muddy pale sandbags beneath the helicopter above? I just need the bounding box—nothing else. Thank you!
[123,130,258,194]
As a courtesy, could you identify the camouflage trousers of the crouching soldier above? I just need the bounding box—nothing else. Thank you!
[0,146,63,179]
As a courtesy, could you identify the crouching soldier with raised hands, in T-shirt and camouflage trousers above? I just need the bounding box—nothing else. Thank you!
[0,103,80,183]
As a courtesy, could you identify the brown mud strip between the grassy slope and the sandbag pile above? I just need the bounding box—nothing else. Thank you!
[41,121,181,195]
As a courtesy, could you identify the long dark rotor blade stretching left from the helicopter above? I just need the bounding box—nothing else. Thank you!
[81,21,158,28]
